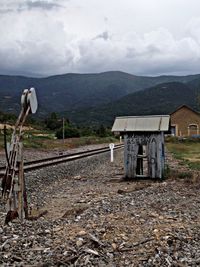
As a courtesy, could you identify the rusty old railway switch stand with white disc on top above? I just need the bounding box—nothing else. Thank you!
[2,88,38,223]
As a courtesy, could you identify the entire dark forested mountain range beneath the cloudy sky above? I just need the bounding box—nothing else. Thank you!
[0,71,200,125]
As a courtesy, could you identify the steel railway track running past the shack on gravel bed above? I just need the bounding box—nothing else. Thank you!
[0,144,124,176]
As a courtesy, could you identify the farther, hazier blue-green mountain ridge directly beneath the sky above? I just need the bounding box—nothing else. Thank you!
[0,71,200,117]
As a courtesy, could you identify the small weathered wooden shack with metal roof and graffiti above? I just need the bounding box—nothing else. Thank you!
[112,115,170,179]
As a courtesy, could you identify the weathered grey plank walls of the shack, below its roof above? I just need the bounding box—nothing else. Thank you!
[124,132,165,178]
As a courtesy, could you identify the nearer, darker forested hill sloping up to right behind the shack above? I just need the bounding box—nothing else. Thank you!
[67,79,200,125]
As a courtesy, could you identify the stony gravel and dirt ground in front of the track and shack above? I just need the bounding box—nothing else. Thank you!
[0,148,200,267]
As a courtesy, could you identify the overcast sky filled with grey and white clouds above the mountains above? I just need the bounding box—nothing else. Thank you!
[0,0,200,76]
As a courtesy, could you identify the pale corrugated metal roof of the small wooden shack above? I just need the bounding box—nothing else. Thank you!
[112,115,170,132]
